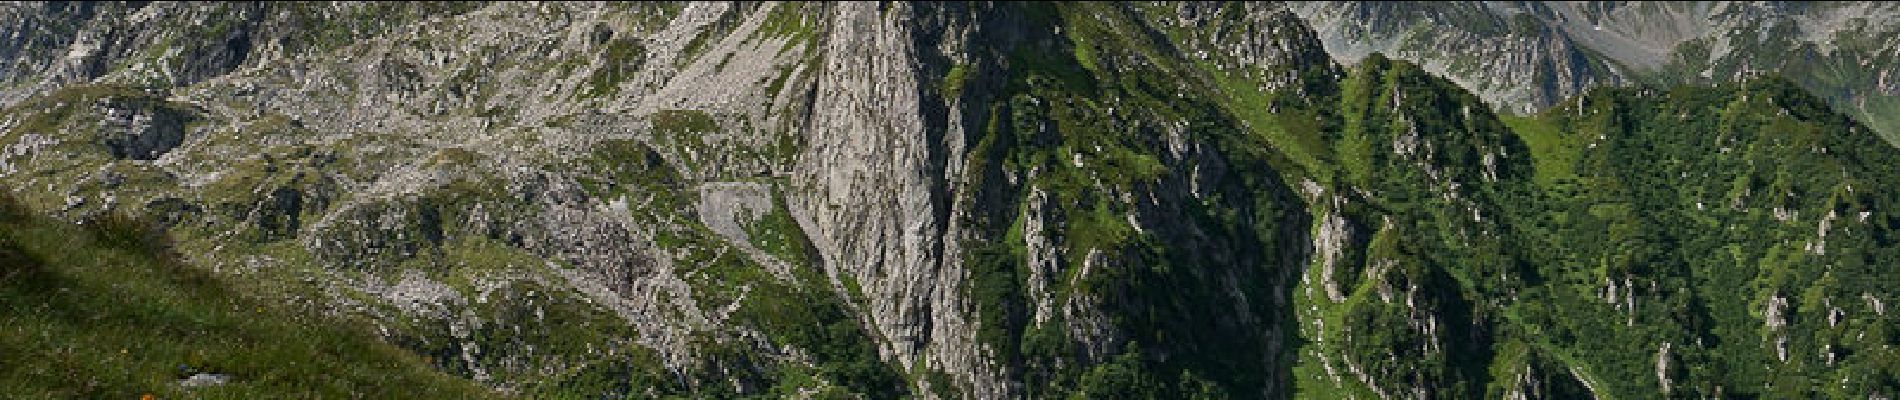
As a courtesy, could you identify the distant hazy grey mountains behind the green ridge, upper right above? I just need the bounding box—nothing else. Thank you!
[1292,2,1900,140]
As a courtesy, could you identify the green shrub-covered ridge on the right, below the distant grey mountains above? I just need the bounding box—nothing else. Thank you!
[1140,3,1896,398]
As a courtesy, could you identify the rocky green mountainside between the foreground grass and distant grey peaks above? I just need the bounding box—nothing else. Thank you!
[0,2,1900,398]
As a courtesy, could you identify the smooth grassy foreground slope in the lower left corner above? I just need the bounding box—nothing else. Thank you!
[0,193,488,398]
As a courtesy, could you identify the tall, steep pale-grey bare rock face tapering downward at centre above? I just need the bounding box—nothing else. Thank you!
[789,4,1003,396]
